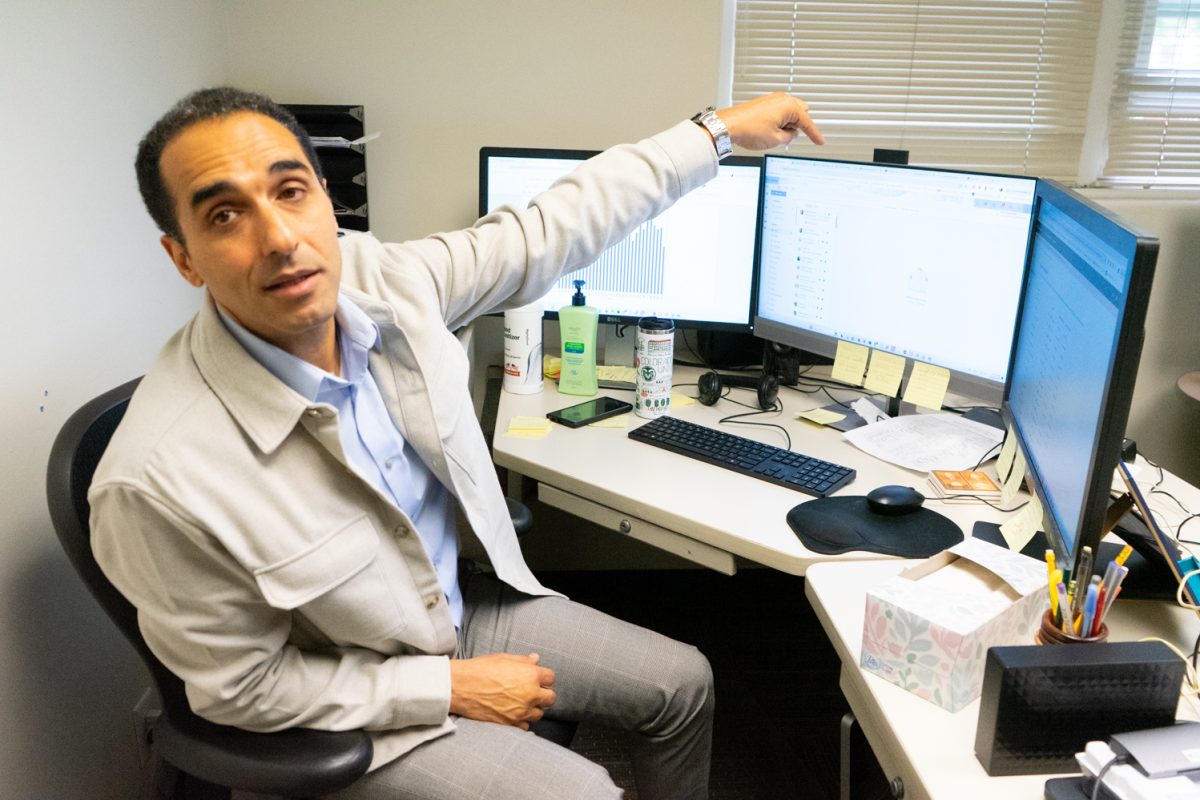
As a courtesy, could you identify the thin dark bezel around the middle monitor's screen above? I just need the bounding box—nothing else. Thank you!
[754,154,1038,407]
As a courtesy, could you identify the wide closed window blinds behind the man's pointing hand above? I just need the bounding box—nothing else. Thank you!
[732,0,1099,181]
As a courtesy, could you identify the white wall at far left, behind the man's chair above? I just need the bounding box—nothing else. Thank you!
[0,0,223,800]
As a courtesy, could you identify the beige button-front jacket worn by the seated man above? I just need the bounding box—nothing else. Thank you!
[89,122,716,765]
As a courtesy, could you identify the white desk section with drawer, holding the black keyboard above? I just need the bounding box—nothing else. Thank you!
[493,367,1006,575]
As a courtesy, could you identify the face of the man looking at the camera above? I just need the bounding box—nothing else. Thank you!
[161,112,342,357]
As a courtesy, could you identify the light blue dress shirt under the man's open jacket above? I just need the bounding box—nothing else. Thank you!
[217,295,462,627]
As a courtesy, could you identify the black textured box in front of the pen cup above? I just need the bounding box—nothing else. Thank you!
[976,642,1184,775]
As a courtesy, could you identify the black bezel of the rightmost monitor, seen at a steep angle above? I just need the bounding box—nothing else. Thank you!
[1001,179,1158,573]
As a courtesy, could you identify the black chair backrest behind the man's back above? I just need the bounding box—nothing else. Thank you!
[46,378,186,708]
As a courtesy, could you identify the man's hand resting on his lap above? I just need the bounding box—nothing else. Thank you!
[450,652,554,730]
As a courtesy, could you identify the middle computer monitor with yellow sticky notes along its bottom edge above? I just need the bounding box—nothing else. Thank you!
[755,156,1037,404]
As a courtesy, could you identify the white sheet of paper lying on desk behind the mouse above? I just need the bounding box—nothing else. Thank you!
[842,409,1004,473]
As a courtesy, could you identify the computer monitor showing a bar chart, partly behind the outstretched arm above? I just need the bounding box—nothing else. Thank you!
[479,148,762,332]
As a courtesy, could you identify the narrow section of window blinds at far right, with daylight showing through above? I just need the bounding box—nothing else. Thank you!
[1097,0,1200,187]
